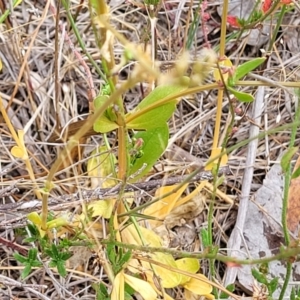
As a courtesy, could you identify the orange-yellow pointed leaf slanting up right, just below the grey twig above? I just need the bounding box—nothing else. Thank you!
[144,184,188,227]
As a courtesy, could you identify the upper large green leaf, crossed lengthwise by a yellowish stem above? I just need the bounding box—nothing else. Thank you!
[126,85,187,130]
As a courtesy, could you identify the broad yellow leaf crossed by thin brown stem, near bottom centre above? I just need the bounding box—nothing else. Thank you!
[152,252,182,288]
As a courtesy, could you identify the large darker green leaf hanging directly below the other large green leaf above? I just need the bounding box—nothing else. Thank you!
[130,124,169,182]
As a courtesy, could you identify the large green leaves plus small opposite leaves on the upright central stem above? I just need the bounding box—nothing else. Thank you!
[94,84,187,181]
